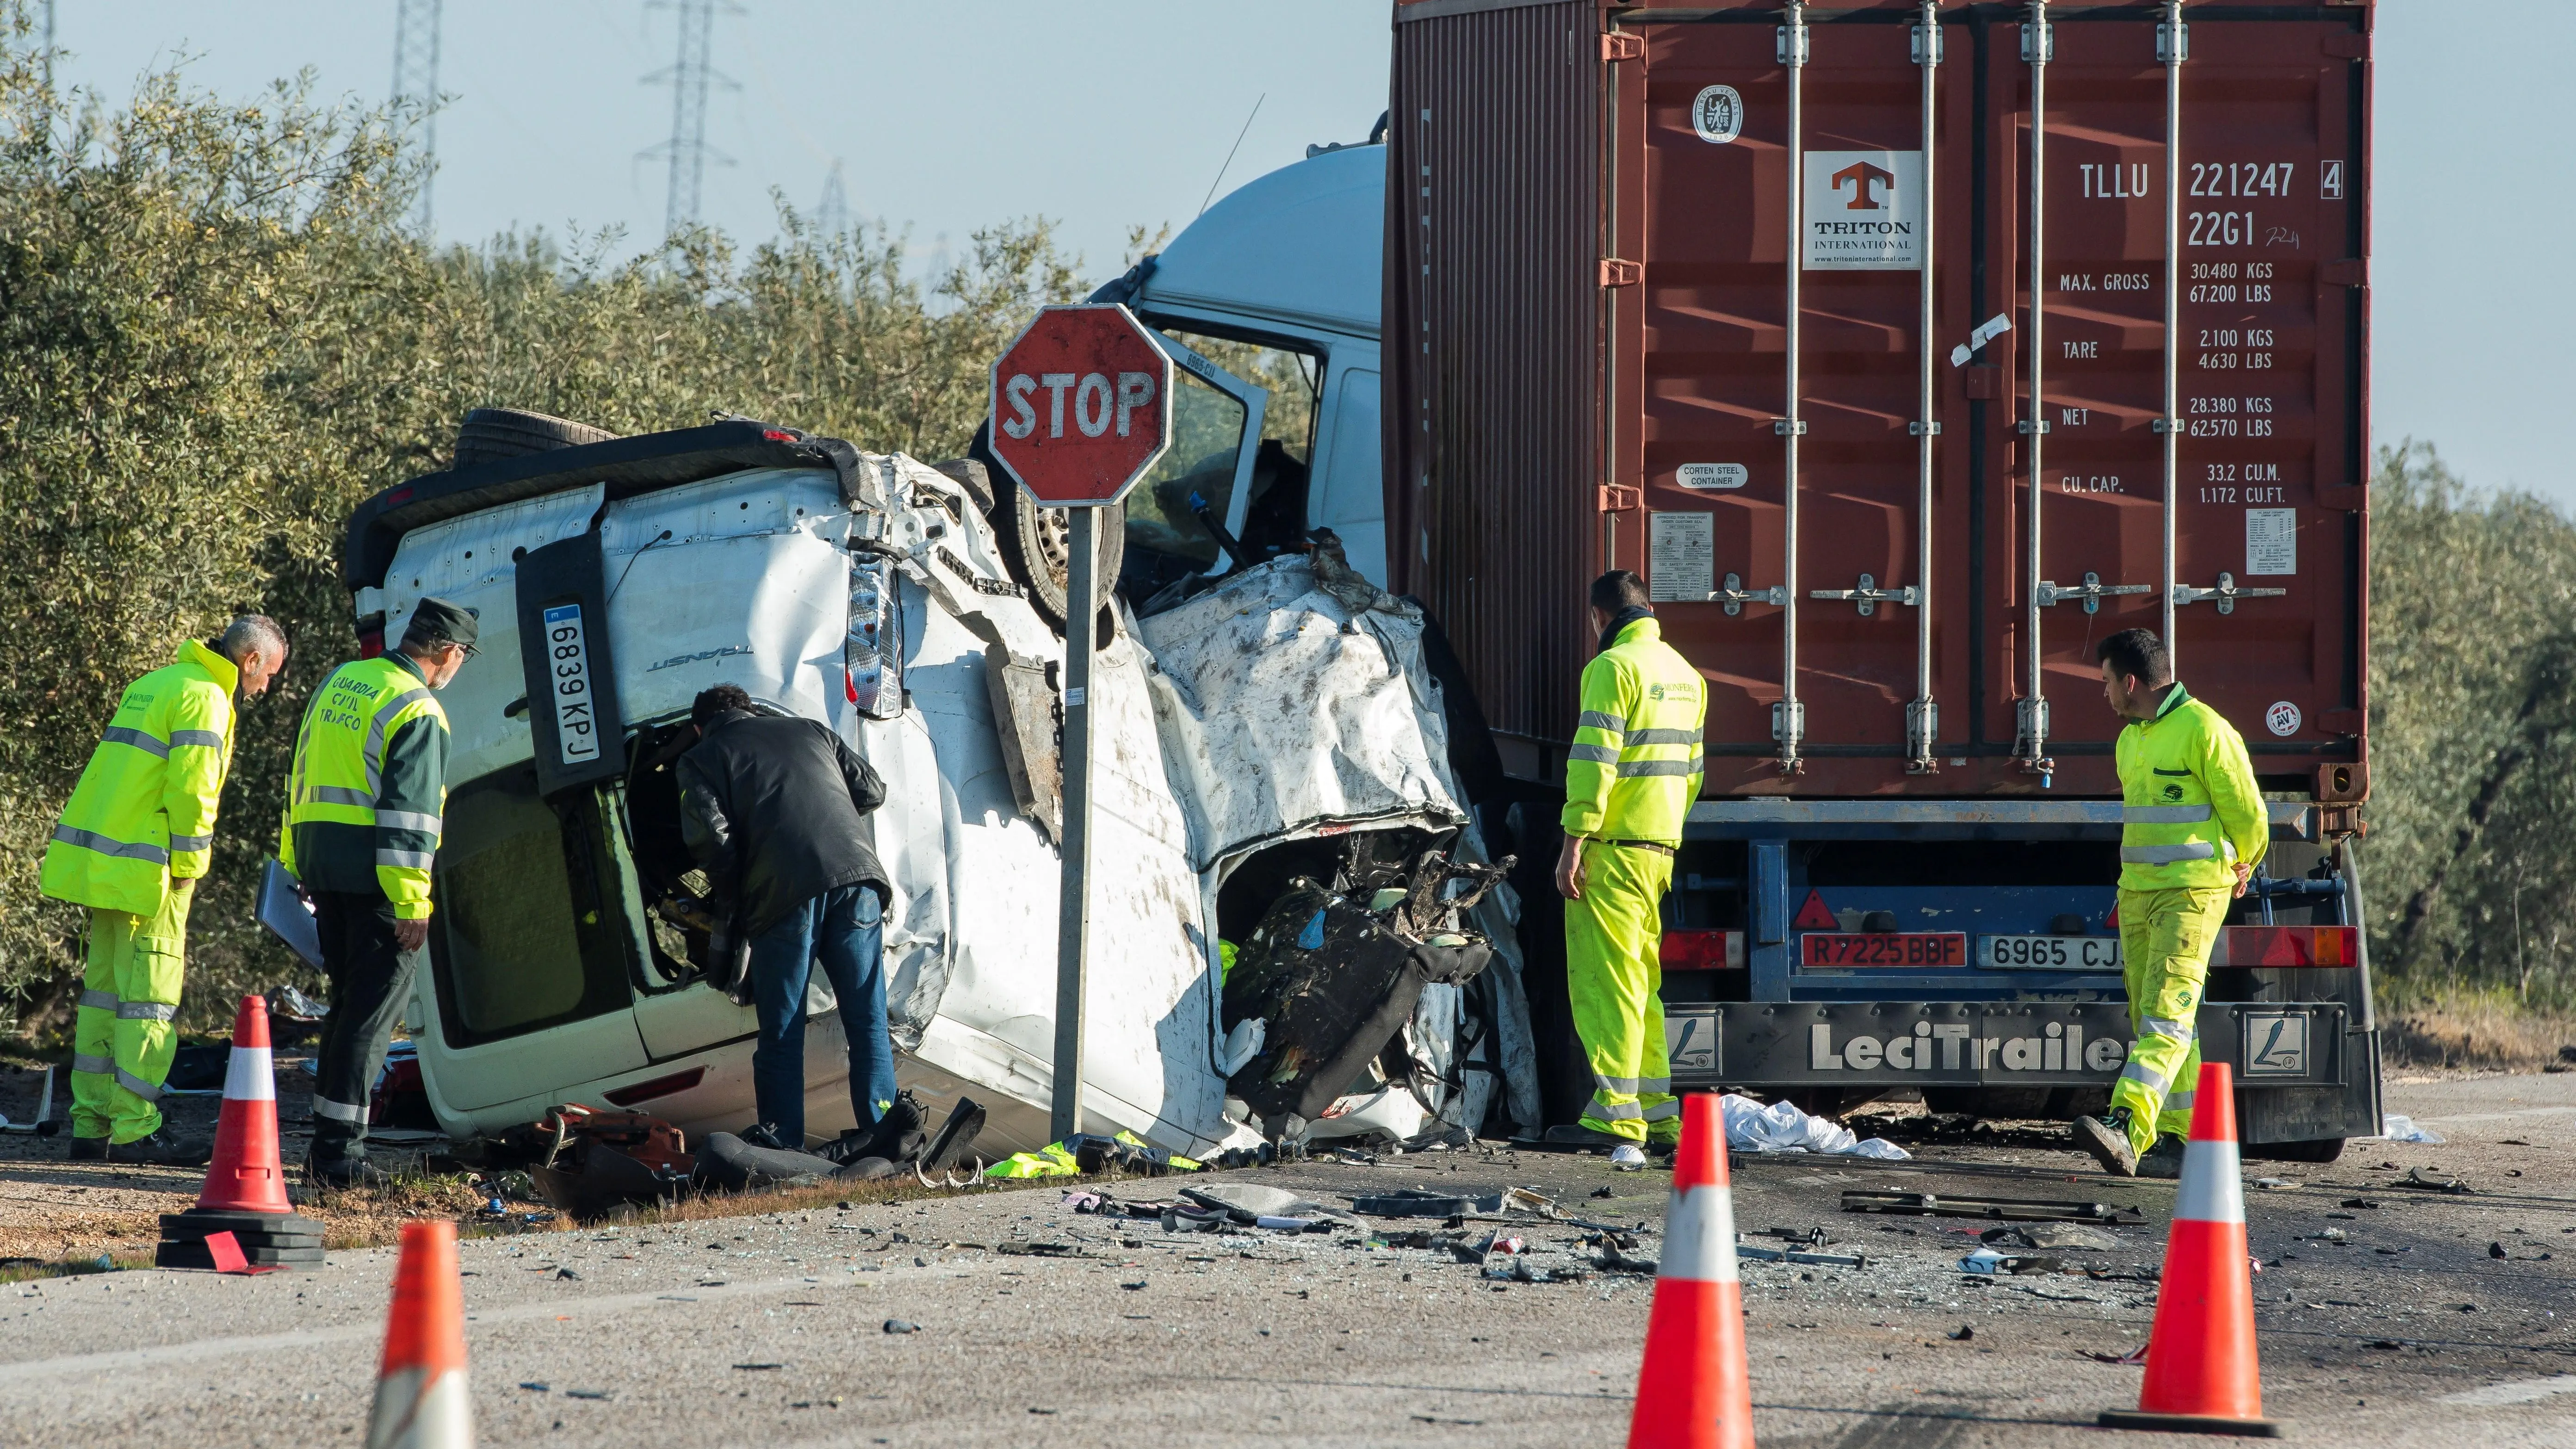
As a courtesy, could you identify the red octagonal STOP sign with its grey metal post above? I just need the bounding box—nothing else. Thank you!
[992,304,1172,1142]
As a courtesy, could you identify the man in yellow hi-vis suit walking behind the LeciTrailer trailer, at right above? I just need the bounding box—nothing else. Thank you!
[2074,629,2272,1178]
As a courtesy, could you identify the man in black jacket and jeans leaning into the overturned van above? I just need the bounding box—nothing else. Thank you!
[680,683,894,1150]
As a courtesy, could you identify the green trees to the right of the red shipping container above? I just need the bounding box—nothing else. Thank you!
[2362,441,2576,1005]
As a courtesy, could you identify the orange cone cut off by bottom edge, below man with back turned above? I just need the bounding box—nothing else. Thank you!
[1628,1093,1754,1449]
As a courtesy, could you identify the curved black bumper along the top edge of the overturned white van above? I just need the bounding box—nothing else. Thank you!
[340,420,832,590]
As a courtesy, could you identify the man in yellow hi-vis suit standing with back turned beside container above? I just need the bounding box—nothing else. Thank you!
[1548,570,1708,1168]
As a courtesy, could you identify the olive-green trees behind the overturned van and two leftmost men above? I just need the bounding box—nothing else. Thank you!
[0,37,1077,1034]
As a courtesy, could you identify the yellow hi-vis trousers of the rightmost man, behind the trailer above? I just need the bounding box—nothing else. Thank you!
[2110,887,2233,1152]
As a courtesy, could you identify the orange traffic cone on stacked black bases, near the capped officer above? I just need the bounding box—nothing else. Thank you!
[152,995,322,1269]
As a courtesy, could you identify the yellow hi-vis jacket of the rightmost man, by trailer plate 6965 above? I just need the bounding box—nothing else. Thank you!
[2115,683,2272,890]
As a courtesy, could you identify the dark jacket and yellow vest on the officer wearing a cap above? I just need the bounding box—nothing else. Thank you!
[278,655,448,921]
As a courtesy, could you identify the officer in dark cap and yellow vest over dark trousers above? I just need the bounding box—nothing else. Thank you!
[278,598,479,1186]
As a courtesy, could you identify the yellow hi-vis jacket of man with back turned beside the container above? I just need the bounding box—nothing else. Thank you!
[1564,619,1708,846]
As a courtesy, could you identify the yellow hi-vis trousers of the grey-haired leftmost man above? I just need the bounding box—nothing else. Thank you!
[72,879,196,1142]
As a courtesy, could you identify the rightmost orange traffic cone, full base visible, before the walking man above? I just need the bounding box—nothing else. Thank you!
[2102,1062,2285,1439]
